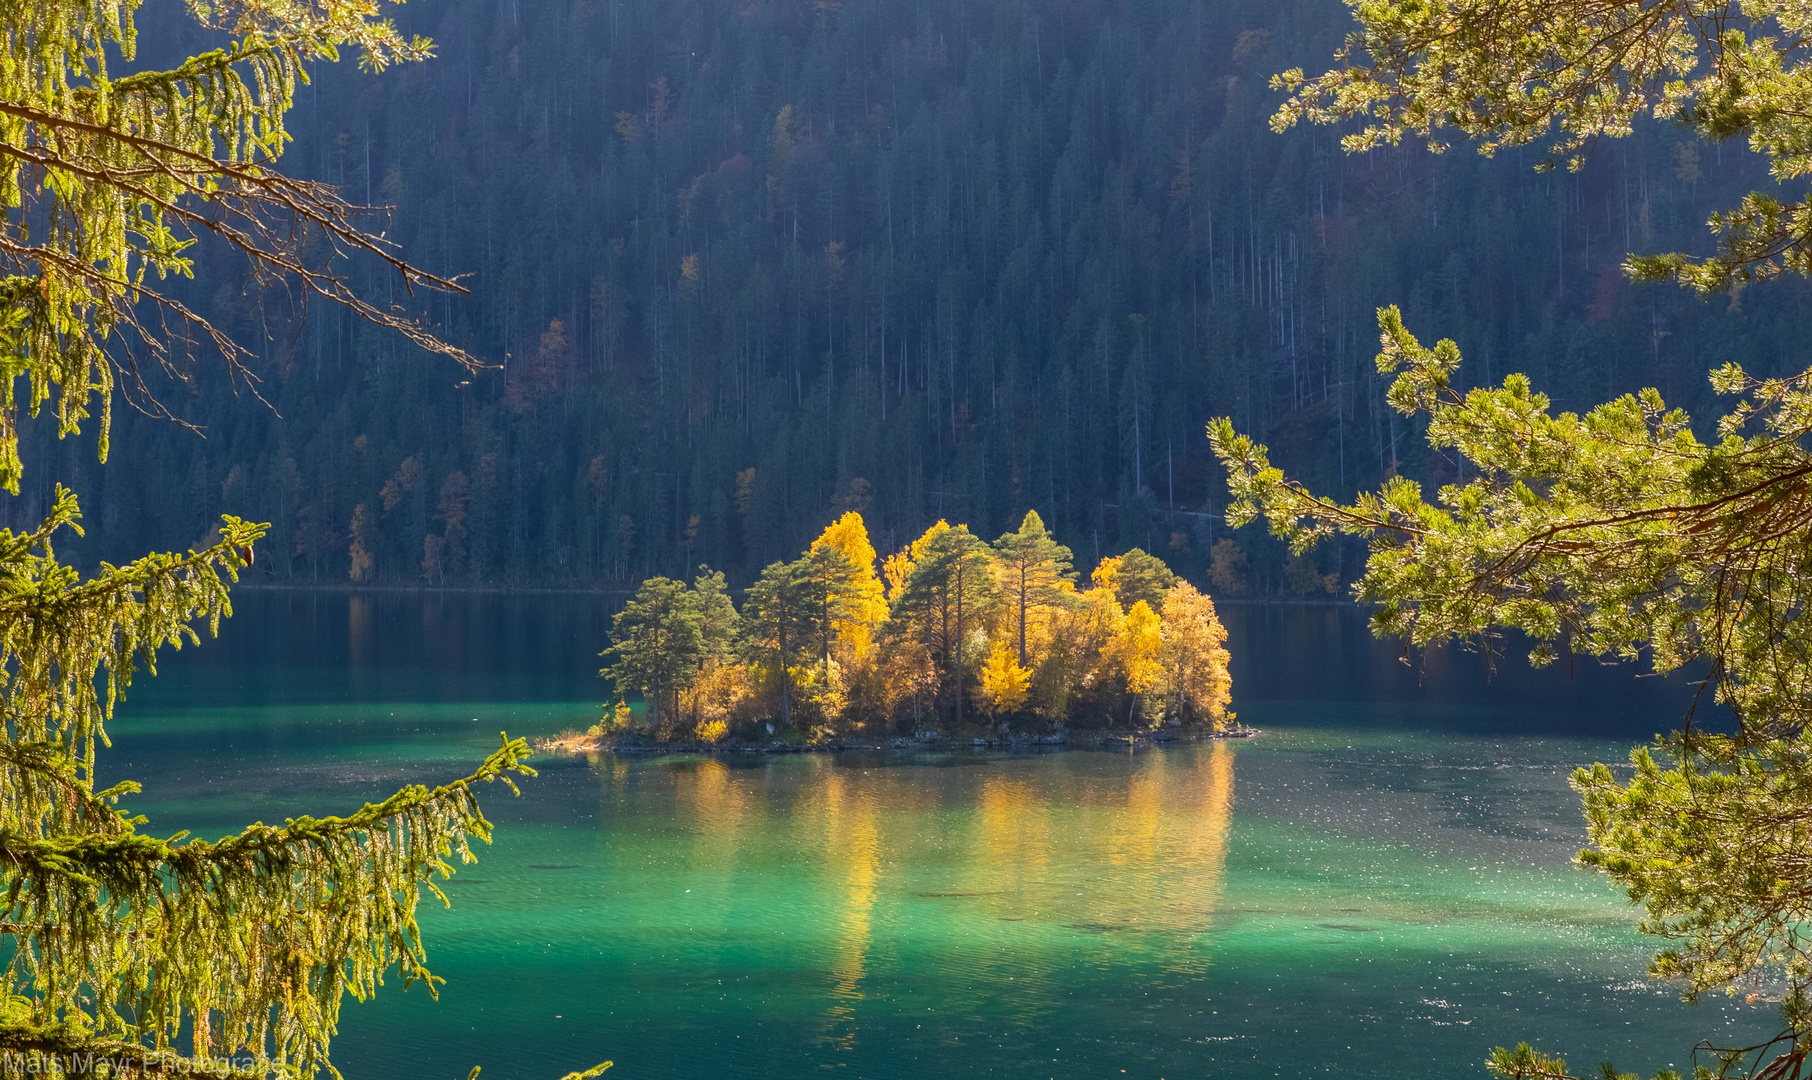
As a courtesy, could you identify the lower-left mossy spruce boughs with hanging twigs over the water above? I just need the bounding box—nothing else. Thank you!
[0,489,533,1076]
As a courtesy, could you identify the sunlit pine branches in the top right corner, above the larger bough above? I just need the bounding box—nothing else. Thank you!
[1272,0,1812,290]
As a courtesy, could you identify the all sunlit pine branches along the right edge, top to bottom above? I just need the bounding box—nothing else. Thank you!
[1209,0,1812,1080]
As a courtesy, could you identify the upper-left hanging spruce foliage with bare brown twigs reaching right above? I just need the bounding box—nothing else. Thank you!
[0,0,475,491]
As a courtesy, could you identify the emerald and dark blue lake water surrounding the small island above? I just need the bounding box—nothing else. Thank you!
[101,593,1776,1080]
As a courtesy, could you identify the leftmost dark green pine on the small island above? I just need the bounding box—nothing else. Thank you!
[598,578,699,725]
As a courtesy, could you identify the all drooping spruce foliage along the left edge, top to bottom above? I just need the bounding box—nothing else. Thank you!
[0,0,603,1078]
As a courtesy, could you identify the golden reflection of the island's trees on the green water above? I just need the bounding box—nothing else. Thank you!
[634,745,1234,1062]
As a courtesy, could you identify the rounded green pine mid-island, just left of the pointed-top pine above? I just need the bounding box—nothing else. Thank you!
[888,526,1000,725]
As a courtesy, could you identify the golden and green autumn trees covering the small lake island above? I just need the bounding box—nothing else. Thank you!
[596,511,1232,743]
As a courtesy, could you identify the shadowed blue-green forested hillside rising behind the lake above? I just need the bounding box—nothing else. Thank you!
[35,0,1812,593]
